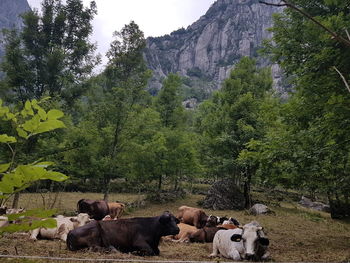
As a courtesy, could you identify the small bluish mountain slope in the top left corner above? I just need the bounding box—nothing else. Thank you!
[0,0,30,67]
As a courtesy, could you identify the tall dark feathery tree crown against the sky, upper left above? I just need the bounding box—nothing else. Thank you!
[1,0,98,106]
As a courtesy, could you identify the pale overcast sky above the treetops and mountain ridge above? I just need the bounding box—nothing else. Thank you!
[28,0,215,66]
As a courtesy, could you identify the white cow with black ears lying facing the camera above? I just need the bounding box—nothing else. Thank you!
[210,221,269,261]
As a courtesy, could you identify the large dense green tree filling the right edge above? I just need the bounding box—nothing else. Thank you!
[266,0,350,219]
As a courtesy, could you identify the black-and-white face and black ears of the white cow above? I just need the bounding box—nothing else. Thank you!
[231,224,269,260]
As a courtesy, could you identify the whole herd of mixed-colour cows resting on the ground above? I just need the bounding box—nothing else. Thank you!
[0,199,269,261]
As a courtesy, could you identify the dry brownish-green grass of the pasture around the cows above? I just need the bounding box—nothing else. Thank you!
[0,193,350,262]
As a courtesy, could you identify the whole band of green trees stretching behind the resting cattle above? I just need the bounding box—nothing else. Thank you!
[0,0,350,231]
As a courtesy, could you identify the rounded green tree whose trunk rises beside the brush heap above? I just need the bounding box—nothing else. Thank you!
[197,57,272,208]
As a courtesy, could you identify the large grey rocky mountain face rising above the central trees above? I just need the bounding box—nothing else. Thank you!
[145,0,281,99]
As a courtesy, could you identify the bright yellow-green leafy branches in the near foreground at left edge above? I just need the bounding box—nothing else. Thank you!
[0,100,67,234]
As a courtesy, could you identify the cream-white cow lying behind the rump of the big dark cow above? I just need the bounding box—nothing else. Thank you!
[30,213,90,241]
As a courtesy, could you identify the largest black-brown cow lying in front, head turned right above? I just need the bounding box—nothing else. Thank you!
[67,211,180,256]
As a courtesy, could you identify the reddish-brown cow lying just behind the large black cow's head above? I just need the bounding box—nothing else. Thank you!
[177,205,208,228]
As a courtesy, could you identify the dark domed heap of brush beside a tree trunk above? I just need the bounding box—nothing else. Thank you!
[203,179,245,210]
